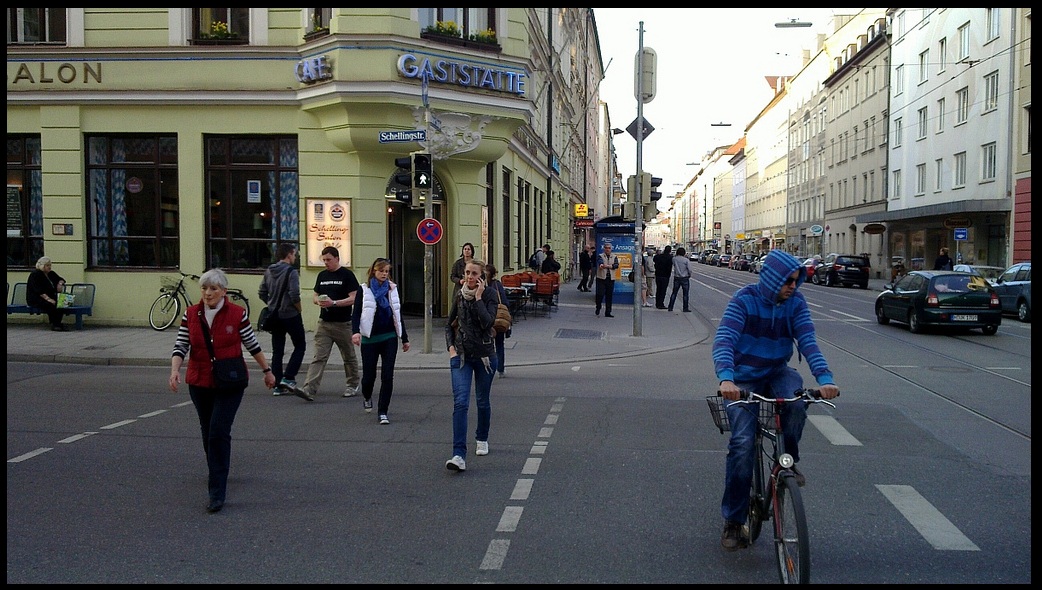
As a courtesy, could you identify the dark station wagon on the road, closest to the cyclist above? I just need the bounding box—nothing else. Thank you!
[875,270,1002,336]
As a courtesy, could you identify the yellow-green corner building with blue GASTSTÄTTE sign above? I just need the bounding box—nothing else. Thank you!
[7,8,602,325]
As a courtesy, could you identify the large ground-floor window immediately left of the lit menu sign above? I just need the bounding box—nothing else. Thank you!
[203,136,300,270]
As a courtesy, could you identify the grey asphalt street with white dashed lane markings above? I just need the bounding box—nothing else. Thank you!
[7,265,1032,584]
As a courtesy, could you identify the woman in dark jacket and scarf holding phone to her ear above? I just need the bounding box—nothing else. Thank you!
[445,260,499,471]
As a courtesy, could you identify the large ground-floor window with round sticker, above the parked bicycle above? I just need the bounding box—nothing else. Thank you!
[84,133,180,268]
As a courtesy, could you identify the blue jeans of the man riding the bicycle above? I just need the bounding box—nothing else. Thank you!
[720,367,807,522]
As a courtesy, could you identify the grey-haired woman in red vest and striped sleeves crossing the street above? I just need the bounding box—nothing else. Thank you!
[169,268,275,513]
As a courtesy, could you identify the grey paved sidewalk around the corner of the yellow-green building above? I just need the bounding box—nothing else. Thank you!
[7,281,716,371]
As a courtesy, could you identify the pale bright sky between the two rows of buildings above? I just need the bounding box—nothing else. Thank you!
[594,8,861,208]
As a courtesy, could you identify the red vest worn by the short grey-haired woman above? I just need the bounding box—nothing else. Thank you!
[184,297,245,387]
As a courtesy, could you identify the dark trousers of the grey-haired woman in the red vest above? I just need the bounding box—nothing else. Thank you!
[189,385,246,501]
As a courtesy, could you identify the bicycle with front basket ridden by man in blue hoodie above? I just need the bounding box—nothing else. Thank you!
[705,389,836,584]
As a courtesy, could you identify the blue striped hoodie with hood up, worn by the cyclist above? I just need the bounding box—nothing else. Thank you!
[713,250,834,386]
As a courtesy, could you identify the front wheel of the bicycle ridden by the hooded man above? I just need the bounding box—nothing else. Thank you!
[774,474,811,584]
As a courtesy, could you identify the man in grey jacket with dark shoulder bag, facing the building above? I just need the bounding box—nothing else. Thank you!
[257,243,307,399]
